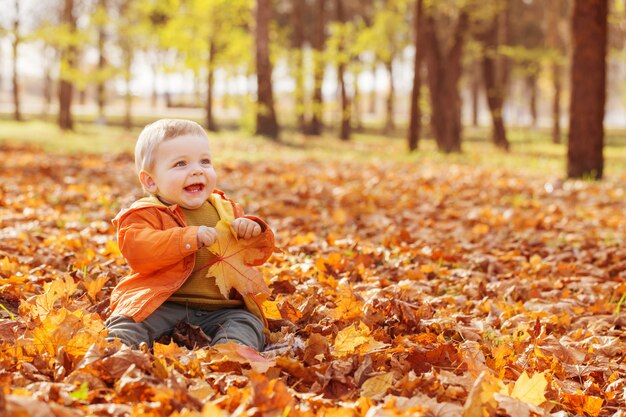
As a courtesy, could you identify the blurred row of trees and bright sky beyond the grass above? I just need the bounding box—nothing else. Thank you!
[0,0,626,177]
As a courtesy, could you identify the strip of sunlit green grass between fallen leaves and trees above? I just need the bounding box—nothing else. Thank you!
[0,120,626,179]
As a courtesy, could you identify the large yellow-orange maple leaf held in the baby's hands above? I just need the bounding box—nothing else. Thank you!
[207,220,274,298]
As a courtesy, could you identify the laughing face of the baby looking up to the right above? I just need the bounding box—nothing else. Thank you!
[140,135,217,209]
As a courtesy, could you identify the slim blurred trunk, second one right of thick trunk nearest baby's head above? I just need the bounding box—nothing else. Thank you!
[308,0,326,135]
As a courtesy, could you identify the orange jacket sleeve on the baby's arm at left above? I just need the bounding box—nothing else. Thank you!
[117,210,198,273]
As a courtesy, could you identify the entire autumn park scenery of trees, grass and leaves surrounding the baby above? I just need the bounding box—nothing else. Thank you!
[0,0,626,417]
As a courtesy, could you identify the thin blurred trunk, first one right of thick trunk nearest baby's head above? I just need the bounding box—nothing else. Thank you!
[292,1,307,133]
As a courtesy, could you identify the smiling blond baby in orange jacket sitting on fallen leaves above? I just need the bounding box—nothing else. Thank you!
[106,119,274,351]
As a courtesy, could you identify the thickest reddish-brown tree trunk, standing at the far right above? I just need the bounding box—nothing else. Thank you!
[567,0,608,179]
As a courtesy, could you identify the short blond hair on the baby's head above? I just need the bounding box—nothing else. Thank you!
[135,119,209,174]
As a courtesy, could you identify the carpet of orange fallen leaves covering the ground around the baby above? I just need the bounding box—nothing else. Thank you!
[0,144,626,417]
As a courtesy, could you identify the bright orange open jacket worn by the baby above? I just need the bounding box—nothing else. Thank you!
[111,190,274,326]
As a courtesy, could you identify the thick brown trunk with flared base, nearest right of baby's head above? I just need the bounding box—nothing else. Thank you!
[256,0,279,139]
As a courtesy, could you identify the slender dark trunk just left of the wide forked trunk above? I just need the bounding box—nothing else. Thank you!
[407,0,424,152]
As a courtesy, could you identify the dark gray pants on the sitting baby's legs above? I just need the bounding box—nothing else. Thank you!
[105,302,265,352]
